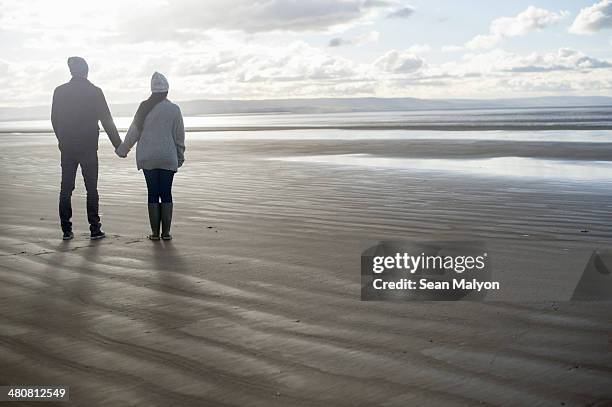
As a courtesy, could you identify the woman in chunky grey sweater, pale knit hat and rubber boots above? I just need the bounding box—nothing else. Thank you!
[116,72,185,240]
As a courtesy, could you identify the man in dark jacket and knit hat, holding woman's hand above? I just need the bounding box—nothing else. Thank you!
[51,57,121,240]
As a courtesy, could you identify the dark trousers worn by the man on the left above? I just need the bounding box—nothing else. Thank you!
[59,150,102,233]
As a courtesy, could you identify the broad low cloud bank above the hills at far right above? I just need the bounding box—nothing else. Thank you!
[381,48,612,98]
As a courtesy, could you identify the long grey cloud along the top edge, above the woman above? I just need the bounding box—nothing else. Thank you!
[120,0,395,40]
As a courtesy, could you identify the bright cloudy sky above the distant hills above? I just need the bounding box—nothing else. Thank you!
[0,0,612,107]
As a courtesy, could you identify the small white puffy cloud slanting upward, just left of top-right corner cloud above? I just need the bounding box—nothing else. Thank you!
[465,6,569,49]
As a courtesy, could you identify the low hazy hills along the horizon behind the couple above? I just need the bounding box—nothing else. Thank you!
[0,96,612,121]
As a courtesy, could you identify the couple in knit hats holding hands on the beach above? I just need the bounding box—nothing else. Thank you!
[51,57,185,240]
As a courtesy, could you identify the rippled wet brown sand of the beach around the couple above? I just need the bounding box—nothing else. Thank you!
[0,135,612,406]
